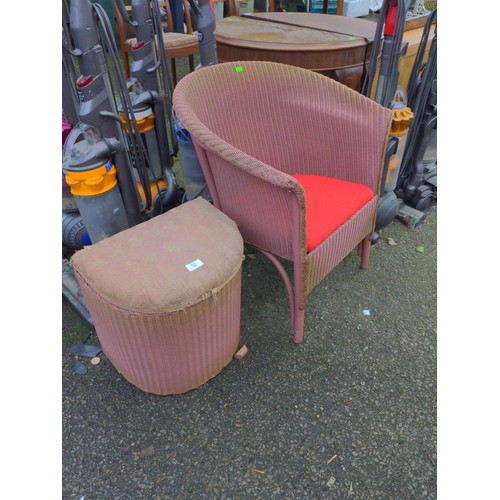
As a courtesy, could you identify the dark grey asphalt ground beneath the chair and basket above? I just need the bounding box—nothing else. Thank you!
[62,208,437,500]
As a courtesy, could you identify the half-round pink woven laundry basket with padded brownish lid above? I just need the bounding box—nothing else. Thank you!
[71,198,243,395]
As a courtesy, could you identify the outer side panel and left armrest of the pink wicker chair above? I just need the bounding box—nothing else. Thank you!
[193,139,306,260]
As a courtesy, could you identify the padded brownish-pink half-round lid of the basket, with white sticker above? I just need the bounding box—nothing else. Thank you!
[71,198,243,313]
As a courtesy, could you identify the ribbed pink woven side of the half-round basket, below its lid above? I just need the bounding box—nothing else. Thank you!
[76,267,241,395]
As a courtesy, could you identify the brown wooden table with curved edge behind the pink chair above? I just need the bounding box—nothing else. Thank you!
[216,12,376,90]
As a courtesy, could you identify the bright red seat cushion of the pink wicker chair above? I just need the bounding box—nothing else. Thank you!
[292,174,374,252]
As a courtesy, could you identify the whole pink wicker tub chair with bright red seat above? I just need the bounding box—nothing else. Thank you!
[173,61,392,343]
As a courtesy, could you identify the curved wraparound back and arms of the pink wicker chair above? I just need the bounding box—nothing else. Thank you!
[173,61,392,258]
